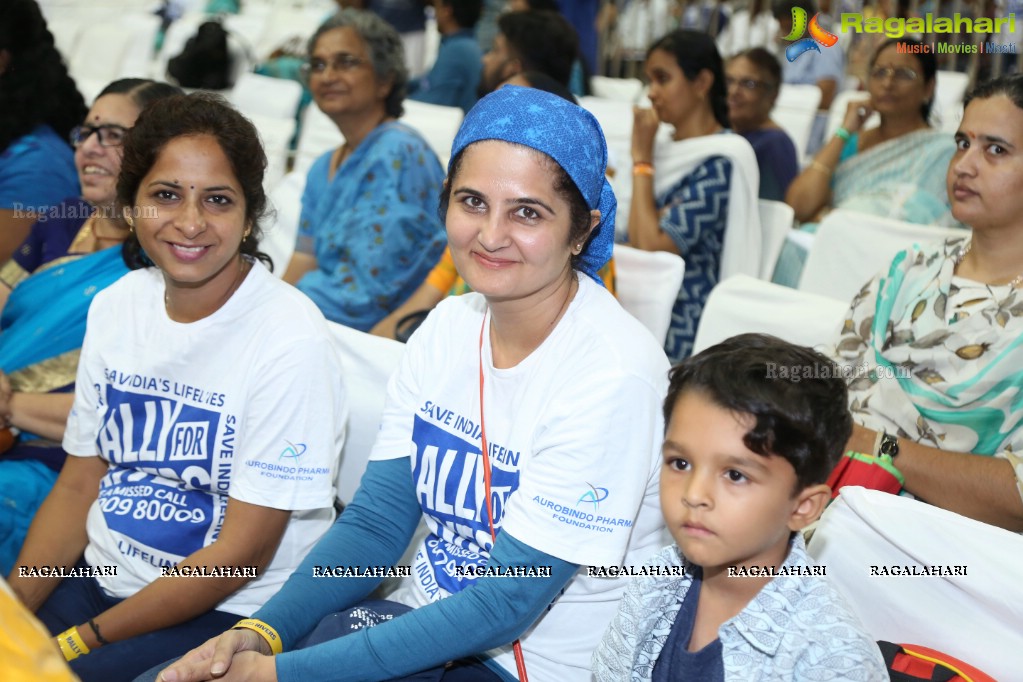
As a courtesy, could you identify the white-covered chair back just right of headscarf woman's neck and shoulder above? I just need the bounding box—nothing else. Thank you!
[615,244,685,343]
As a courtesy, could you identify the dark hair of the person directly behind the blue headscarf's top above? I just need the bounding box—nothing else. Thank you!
[497,10,579,85]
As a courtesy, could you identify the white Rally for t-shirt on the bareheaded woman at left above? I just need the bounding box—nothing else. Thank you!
[63,264,347,616]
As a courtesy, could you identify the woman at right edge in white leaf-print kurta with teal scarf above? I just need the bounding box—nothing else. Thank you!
[835,76,1023,532]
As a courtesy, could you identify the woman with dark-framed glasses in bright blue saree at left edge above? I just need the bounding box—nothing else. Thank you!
[0,79,179,575]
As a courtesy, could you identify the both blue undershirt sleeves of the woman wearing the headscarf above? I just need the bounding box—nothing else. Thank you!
[254,458,578,682]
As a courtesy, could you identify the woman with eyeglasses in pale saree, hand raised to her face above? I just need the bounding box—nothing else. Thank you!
[774,38,957,286]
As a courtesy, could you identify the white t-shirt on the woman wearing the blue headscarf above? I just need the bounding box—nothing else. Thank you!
[370,276,668,681]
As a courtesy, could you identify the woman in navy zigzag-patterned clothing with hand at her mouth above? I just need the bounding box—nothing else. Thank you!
[629,30,731,363]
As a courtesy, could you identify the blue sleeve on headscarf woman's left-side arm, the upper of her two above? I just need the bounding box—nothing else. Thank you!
[253,457,421,646]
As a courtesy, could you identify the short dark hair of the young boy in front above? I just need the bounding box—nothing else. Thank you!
[664,334,852,491]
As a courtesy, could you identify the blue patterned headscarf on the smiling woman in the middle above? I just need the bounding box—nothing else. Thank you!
[448,85,618,286]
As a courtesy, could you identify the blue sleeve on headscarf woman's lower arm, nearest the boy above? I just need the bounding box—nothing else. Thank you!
[267,533,579,682]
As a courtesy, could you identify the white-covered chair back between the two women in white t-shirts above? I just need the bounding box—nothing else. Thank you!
[327,322,405,504]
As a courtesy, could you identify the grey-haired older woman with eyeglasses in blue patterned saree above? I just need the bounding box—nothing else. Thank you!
[284,9,446,331]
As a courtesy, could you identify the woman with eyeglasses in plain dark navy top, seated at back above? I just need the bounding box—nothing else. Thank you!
[724,47,799,201]
